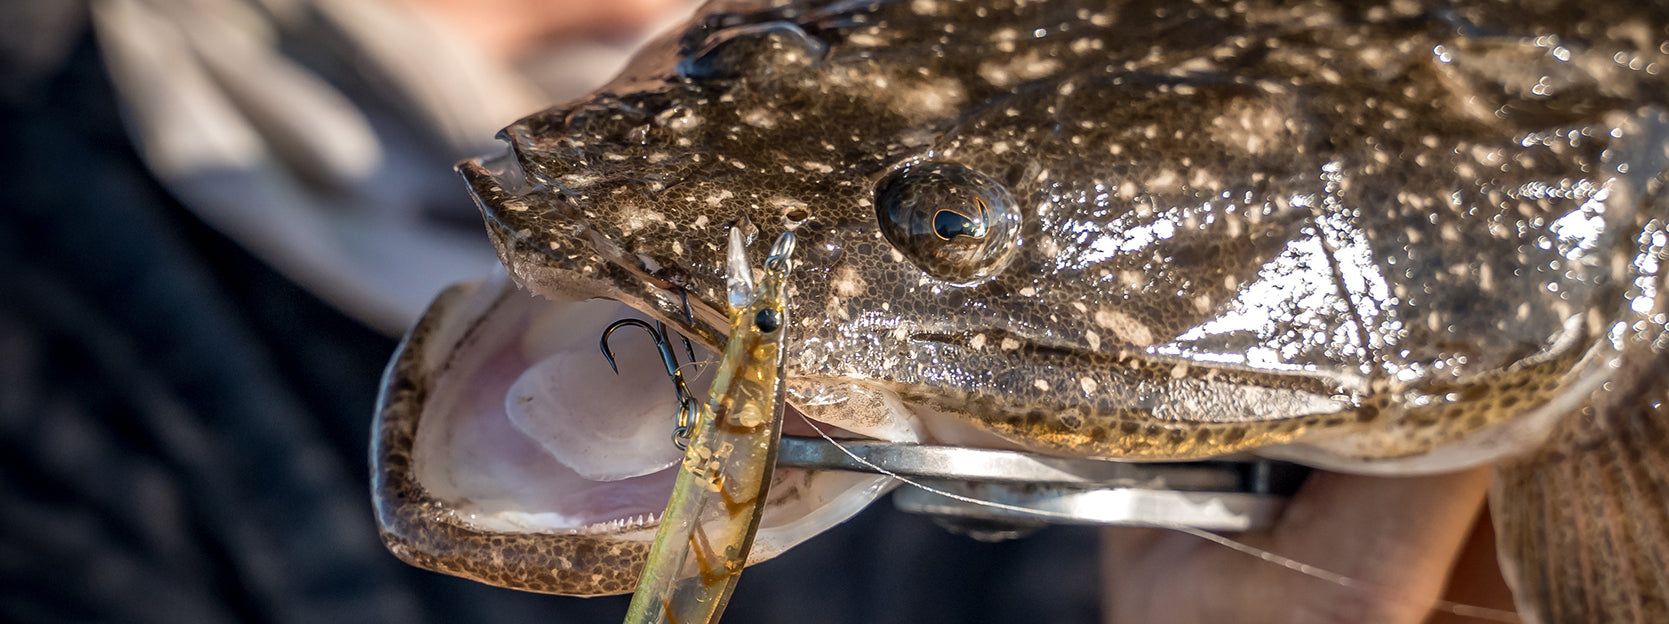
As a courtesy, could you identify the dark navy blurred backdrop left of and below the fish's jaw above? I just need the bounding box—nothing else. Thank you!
[0,0,1098,622]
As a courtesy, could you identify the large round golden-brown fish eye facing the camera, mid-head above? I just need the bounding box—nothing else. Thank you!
[875,162,1020,285]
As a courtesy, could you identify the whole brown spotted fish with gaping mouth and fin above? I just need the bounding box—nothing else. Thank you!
[372,0,1669,622]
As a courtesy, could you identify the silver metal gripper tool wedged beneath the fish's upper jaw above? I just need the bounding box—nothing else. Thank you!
[776,435,1308,539]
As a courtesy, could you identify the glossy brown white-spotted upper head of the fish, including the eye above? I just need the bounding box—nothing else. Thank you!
[375,0,1669,597]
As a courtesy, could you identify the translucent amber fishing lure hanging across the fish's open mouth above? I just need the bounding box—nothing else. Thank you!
[626,229,794,624]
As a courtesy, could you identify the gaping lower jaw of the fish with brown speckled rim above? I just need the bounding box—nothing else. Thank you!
[372,277,890,596]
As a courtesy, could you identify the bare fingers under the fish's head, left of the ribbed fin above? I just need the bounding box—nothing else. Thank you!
[1102,467,1510,624]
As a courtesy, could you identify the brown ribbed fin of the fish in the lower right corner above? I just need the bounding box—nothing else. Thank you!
[1490,345,1669,624]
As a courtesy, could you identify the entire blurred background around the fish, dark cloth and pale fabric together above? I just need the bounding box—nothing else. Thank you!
[0,0,1098,622]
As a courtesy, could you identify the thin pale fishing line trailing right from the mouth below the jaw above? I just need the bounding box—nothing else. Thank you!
[799,414,1520,622]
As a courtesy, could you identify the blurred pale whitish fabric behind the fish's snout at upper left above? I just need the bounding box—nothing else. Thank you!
[92,0,677,334]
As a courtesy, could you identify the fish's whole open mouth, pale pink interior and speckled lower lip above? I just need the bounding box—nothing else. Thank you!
[372,271,890,594]
